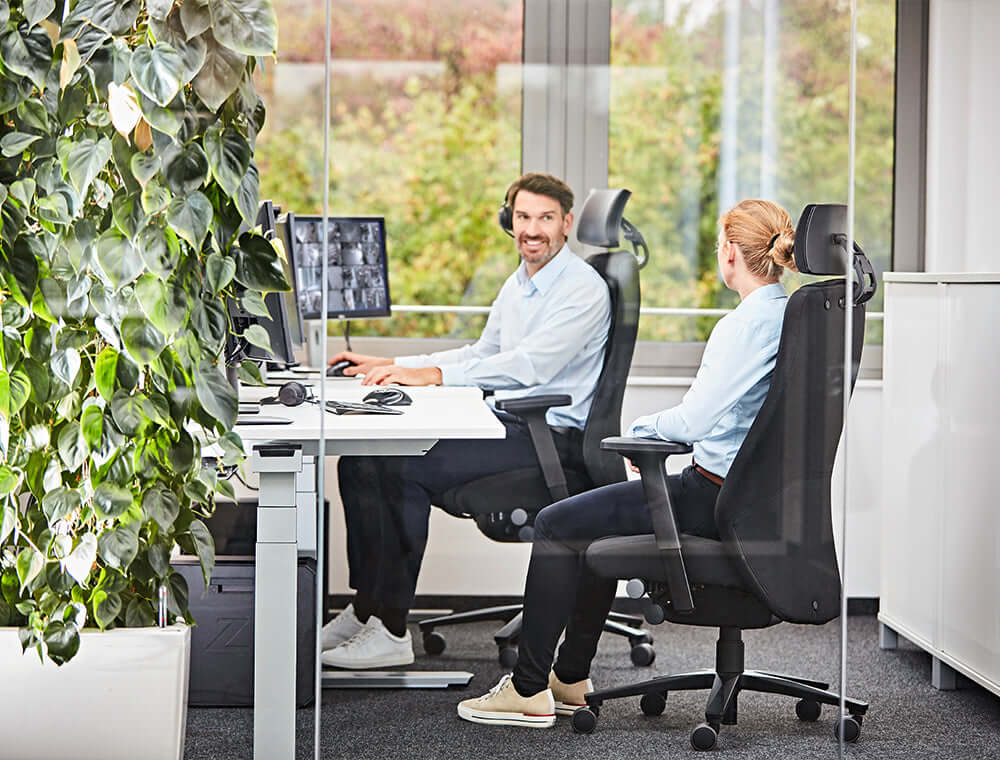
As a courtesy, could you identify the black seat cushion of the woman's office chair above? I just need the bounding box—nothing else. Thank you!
[587,533,749,590]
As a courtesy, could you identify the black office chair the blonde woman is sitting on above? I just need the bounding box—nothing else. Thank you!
[573,205,876,750]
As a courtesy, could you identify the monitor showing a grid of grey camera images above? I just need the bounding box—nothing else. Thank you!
[291,216,391,319]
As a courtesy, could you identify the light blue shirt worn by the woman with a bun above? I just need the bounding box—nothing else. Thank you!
[627,283,788,478]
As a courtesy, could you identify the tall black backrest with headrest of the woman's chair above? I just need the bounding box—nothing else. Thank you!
[715,202,870,623]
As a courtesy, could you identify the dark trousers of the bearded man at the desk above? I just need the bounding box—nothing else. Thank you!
[337,412,582,609]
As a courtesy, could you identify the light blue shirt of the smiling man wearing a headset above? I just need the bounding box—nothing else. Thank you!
[395,245,611,429]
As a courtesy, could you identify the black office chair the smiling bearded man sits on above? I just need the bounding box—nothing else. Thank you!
[420,189,656,668]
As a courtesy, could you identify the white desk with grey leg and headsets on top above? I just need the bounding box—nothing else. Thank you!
[236,378,505,760]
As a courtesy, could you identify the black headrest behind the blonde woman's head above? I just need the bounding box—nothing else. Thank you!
[794,203,878,304]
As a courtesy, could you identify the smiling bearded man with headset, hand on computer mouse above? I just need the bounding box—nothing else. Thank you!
[323,173,611,668]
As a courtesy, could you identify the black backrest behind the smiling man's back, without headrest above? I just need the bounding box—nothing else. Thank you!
[583,251,639,486]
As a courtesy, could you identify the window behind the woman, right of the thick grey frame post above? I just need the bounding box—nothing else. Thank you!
[608,0,895,342]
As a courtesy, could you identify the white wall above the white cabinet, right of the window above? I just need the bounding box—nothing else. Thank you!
[926,0,1000,272]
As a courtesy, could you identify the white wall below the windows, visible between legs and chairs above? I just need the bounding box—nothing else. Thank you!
[326,377,882,597]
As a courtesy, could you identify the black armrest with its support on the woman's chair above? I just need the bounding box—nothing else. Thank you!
[601,437,694,612]
